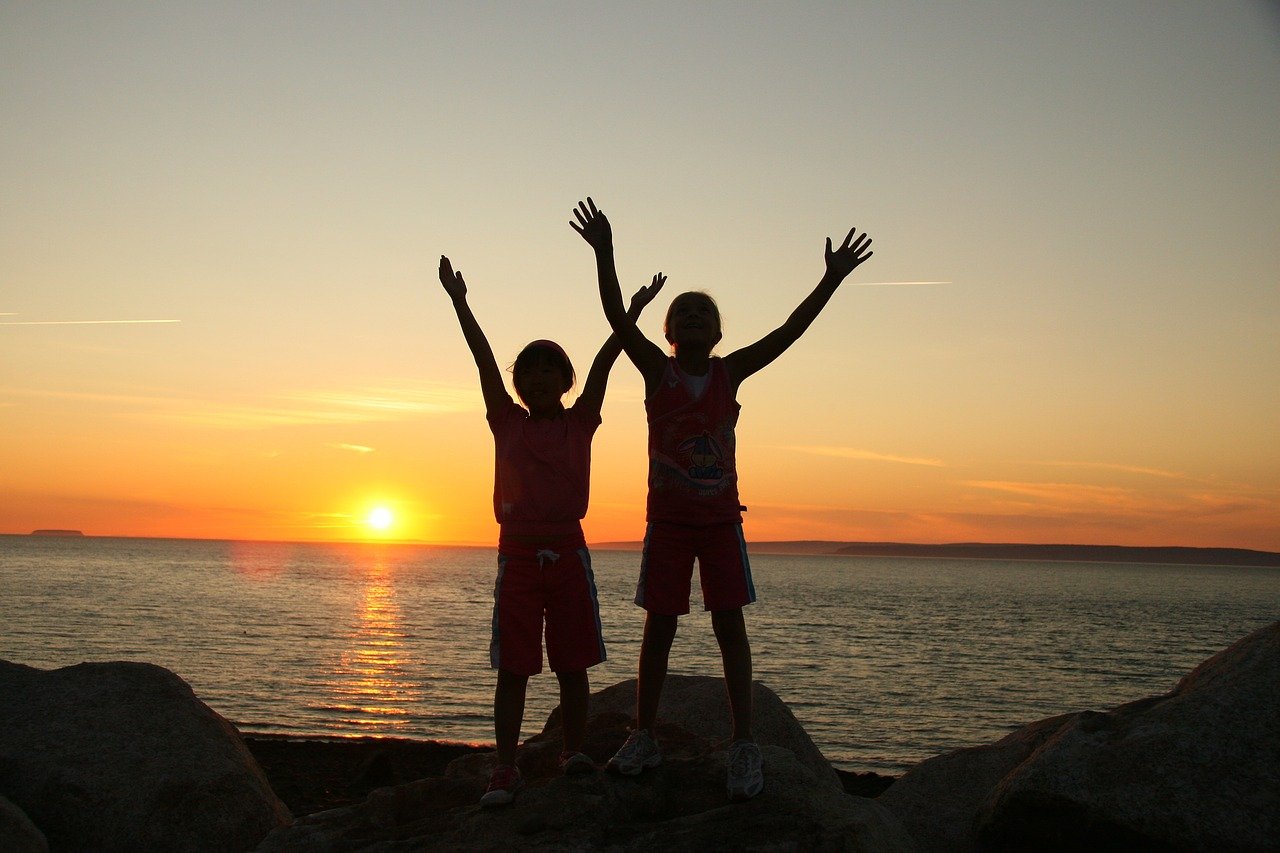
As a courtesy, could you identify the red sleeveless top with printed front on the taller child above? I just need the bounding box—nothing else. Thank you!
[644,357,742,525]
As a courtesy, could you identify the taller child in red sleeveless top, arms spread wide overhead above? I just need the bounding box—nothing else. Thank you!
[570,199,872,799]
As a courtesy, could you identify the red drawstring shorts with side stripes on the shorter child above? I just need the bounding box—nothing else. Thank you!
[489,538,604,675]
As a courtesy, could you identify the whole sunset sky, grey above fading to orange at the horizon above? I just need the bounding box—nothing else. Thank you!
[0,0,1280,551]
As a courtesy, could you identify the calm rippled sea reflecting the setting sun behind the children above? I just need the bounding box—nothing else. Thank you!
[0,535,1280,774]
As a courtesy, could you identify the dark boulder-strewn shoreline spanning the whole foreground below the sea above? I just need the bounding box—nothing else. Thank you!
[0,622,1280,853]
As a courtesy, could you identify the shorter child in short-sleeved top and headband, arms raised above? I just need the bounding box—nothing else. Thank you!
[440,255,664,806]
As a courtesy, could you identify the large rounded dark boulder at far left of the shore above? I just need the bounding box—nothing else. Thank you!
[0,661,291,853]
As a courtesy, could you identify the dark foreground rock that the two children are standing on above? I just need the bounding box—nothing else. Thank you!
[259,679,911,853]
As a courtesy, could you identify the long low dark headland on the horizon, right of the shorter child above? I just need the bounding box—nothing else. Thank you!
[591,539,1280,567]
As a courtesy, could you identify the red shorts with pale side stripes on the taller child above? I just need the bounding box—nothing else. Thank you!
[636,521,755,616]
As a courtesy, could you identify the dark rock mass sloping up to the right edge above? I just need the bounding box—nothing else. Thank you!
[878,622,1280,850]
